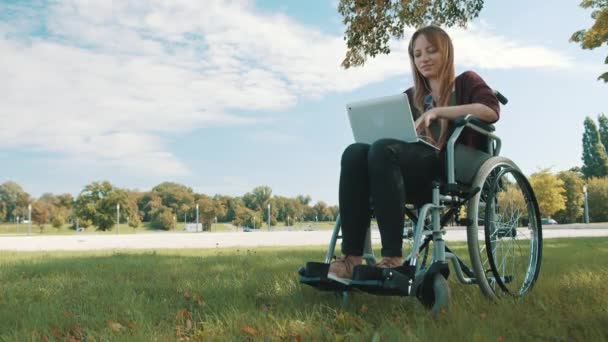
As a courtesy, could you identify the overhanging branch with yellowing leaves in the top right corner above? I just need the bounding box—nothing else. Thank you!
[570,0,608,82]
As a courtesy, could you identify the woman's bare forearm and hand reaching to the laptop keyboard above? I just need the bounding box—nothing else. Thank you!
[416,103,498,133]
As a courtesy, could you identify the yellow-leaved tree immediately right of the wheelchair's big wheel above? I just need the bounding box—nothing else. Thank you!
[529,169,566,217]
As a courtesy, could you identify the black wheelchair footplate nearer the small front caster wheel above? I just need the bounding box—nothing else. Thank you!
[350,265,413,296]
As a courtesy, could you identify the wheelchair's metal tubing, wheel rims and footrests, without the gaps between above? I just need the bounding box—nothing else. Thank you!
[300,92,542,315]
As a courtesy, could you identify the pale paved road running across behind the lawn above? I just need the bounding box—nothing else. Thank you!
[0,223,608,251]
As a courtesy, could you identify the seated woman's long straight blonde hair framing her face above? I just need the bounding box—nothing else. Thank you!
[408,25,455,148]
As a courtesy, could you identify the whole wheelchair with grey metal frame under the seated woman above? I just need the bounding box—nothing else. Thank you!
[298,91,542,316]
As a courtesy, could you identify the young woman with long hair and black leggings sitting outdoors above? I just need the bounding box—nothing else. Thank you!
[328,26,500,280]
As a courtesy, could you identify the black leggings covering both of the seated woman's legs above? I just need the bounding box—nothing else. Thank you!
[339,139,443,257]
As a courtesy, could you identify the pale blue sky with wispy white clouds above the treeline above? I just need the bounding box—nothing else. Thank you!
[0,0,608,205]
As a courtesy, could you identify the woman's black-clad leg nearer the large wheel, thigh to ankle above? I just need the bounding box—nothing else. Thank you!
[368,139,441,257]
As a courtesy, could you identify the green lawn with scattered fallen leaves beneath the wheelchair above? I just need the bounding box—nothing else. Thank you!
[0,238,608,341]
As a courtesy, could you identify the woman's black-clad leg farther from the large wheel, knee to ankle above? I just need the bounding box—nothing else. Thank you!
[339,143,370,256]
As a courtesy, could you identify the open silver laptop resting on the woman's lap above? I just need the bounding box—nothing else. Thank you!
[346,93,437,149]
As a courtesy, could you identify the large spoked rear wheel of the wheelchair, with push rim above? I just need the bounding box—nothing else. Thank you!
[467,157,542,299]
